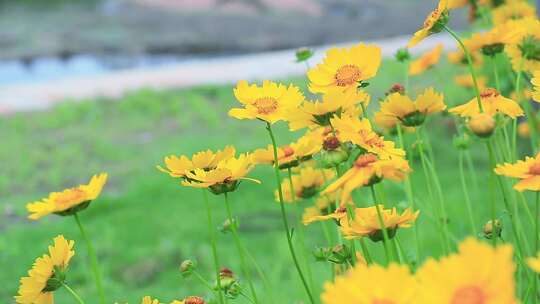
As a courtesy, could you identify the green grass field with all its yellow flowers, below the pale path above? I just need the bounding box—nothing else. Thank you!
[5,0,540,304]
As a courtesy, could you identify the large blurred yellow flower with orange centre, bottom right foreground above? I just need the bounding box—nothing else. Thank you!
[415,238,518,304]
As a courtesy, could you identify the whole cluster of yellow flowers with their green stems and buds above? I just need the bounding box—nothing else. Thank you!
[15,0,540,304]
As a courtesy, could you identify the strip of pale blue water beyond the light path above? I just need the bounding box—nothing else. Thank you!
[0,55,192,86]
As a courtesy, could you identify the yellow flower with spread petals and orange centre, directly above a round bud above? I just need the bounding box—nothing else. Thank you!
[448,88,524,118]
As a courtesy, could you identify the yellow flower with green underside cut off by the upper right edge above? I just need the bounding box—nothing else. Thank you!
[505,18,540,73]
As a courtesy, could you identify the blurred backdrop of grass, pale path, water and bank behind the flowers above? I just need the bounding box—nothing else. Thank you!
[0,0,474,303]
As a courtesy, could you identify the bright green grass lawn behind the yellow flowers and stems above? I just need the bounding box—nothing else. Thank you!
[0,58,536,303]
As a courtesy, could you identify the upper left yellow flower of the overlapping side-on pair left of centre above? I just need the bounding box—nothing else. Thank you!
[157,146,236,178]
